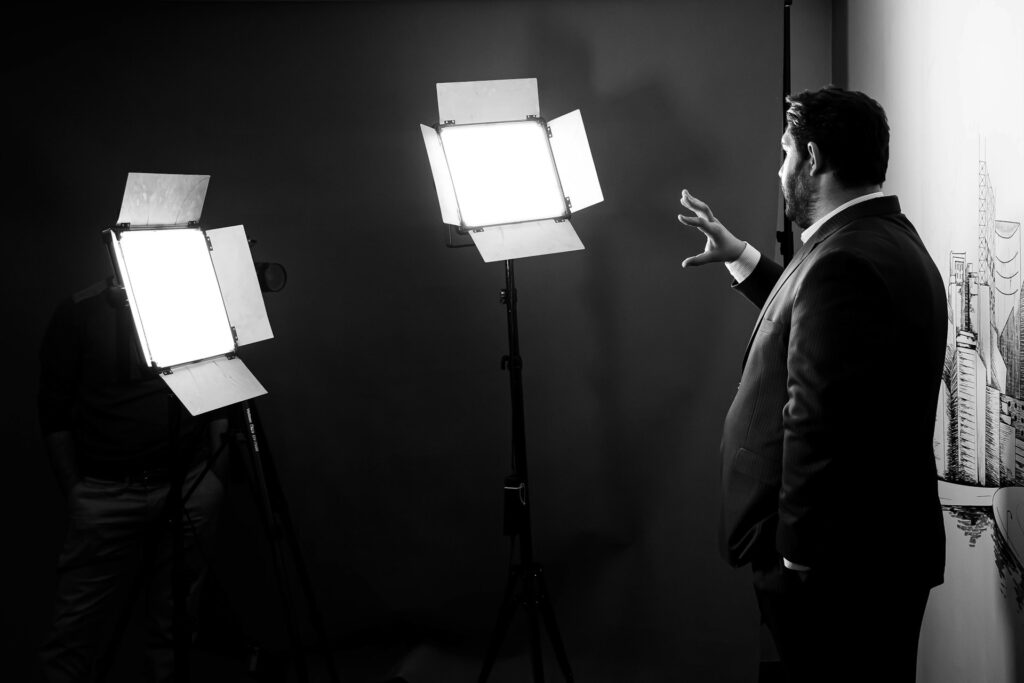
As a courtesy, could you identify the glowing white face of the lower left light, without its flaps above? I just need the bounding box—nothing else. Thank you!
[114,228,234,368]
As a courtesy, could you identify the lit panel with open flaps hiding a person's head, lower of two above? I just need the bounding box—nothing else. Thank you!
[106,173,273,415]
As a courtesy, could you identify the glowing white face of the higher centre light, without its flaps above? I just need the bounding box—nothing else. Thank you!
[441,121,567,227]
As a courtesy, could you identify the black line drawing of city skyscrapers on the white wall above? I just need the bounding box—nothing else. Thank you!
[933,160,1024,614]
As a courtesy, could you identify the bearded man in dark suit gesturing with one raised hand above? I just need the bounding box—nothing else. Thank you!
[679,87,947,682]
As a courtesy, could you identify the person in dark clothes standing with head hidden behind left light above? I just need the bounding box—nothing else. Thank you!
[39,282,227,682]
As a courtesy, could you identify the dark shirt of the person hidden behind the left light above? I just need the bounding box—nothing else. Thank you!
[39,283,210,472]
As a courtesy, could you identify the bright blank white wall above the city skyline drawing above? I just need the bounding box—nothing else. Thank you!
[848,0,1024,273]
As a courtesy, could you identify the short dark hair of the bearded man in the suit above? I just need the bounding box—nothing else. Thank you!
[785,85,889,187]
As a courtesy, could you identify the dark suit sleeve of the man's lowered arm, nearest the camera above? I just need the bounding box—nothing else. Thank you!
[776,252,892,567]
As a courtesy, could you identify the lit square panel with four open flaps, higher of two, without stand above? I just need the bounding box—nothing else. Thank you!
[420,79,604,261]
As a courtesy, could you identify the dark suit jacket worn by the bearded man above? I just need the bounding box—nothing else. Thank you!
[721,197,947,586]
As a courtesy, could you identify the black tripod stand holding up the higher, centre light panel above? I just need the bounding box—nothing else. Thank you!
[478,260,573,683]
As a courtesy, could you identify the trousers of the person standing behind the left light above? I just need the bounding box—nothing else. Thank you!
[40,462,223,683]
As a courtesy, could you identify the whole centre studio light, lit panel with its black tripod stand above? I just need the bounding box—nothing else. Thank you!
[420,78,604,683]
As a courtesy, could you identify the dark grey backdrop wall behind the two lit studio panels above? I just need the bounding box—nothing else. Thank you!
[2,0,827,681]
